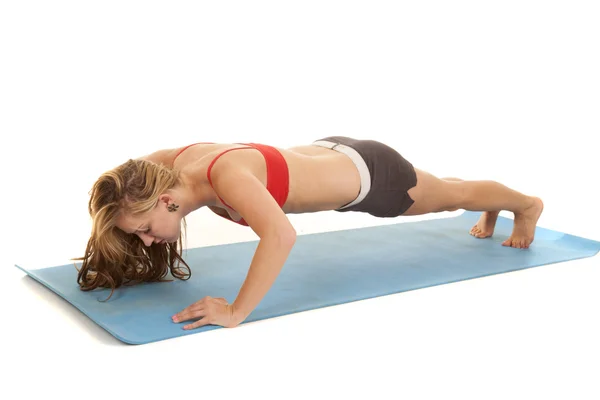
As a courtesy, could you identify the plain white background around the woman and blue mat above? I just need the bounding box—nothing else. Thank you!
[0,0,600,399]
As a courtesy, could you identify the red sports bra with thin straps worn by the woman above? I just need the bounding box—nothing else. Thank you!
[173,142,289,226]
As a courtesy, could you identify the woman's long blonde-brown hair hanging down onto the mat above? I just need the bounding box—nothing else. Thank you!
[73,160,191,298]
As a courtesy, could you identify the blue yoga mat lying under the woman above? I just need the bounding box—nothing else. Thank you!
[17,212,600,344]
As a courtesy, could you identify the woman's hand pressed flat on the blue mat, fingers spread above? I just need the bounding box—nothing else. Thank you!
[171,296,242,329]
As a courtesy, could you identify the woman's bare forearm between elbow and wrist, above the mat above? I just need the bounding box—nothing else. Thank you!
[233,234,296,320]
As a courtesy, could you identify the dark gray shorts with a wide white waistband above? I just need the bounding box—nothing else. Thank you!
[312,136,417,217]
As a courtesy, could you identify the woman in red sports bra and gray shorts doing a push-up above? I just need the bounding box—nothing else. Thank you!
[78,136,543,329]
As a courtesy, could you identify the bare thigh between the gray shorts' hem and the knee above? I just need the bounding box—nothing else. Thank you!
[404,168,464,215]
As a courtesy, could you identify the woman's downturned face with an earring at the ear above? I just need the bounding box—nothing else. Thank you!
[117,195,181,246]
